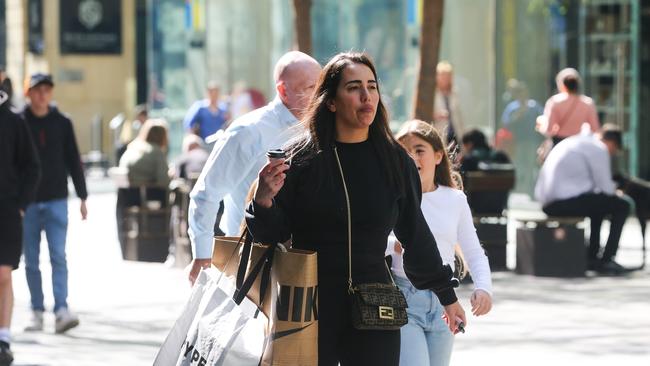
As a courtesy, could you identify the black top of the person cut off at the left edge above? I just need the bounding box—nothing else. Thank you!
[0,96,40,209]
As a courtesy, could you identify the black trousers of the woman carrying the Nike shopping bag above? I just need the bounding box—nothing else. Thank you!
[318,283,400,366]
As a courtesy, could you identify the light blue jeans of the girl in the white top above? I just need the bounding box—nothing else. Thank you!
[395,276,454,366]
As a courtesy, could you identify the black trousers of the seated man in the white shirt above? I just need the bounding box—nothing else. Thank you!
[543,193,630,261]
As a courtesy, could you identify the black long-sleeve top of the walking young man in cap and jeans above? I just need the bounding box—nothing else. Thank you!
[23,106,88,202]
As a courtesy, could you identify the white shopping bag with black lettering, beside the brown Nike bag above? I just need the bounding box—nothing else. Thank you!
[154,269,269,366]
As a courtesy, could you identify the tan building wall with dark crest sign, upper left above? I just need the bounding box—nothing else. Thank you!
[6,0,136,152]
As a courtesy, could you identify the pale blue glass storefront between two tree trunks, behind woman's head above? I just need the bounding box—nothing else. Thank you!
[312,0,408,121]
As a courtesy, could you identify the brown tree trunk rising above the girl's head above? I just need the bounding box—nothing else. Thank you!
[413,0,445,123]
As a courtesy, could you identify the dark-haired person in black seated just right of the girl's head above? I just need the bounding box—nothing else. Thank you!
[460,129,514,215]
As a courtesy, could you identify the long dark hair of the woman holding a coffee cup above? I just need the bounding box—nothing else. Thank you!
[287,52,402,188]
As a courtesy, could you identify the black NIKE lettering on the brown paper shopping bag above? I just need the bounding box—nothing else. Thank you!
[276,286,318,322]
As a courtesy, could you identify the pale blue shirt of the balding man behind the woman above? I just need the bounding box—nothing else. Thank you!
[188,96,298,259]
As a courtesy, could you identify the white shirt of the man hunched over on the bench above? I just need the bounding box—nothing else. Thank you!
[535,129,616,206]
